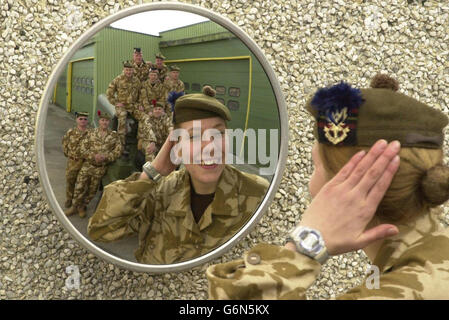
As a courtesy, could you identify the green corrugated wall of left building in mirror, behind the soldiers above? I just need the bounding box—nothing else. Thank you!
[95,27,160,107]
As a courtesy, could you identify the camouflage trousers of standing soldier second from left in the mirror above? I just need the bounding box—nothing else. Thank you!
[72,161,107,208]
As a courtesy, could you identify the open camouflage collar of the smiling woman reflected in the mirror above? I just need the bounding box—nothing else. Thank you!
[167,166,240,233]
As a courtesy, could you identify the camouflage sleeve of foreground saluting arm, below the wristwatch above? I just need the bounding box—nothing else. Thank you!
[206,243,321,300]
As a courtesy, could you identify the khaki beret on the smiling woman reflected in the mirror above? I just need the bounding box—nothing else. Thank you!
[173,86,231,124]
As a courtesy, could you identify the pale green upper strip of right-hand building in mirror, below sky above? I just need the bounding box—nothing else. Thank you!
[159,21,228,41]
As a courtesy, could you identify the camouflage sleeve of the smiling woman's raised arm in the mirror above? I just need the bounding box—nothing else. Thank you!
[87,172,156,242]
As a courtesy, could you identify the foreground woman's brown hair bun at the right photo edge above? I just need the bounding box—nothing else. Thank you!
[421,165,449,207]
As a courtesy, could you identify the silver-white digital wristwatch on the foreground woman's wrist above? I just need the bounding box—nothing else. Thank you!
[287,226,329,264]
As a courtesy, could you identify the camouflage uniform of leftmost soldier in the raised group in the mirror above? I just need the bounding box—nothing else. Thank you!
[106,74,140,145]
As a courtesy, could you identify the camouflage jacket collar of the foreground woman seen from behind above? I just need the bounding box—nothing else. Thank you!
[373,208,441,272]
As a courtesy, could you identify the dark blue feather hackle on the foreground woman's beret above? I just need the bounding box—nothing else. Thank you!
[311,81,363,123]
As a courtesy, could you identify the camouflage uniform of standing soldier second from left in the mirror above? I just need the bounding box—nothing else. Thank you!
[73,128,122,208]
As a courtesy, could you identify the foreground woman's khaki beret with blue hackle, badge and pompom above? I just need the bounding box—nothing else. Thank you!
[306,74,448,149]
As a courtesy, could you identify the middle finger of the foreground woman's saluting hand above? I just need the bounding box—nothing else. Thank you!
[358,141,401,195]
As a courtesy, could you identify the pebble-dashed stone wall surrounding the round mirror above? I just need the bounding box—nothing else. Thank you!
[0,0,449,299]
